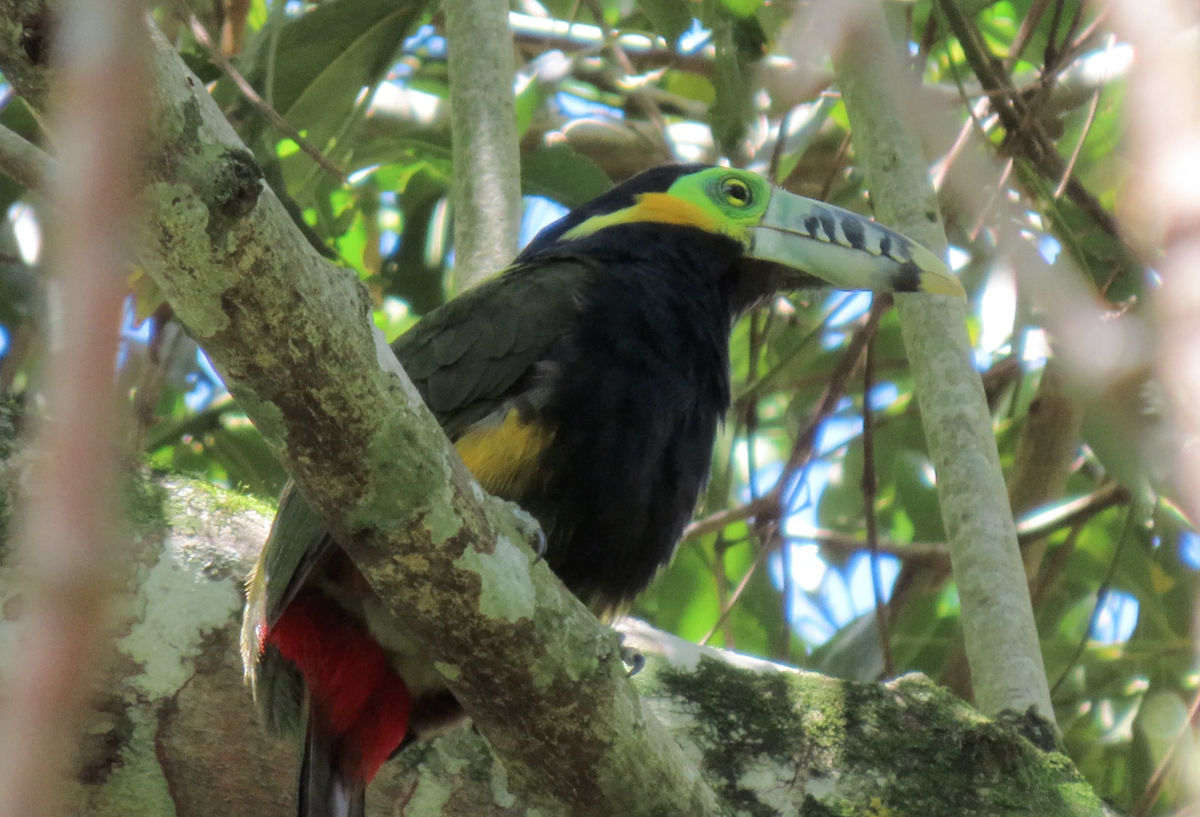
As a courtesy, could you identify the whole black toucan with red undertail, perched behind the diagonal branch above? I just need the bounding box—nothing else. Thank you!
[241,164,965,817]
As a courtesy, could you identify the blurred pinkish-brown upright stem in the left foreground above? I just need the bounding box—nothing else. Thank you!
[0,0,146,817]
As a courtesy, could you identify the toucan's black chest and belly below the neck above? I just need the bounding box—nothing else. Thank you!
[518,296,728,606]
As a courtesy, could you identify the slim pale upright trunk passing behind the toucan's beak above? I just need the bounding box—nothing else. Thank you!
[835,0,1054,720]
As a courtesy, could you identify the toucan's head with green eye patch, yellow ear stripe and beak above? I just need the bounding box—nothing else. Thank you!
[518,164,966,298]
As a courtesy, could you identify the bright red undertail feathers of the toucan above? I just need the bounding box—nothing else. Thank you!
[266,593,413,783]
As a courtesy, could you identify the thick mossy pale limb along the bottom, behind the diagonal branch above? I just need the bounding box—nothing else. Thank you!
[0,472,1111,817]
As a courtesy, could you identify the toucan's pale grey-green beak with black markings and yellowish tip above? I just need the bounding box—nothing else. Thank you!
[746,188,966,299]
